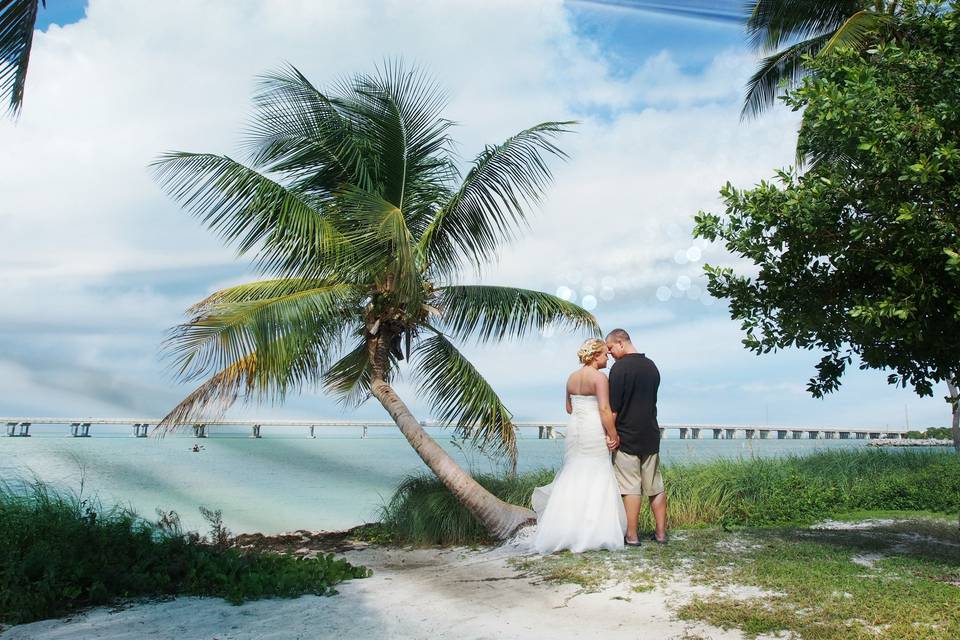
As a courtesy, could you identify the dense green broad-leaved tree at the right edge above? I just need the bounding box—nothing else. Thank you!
[694,7,960,453]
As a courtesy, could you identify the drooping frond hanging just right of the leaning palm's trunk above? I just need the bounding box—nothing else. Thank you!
[414,330,517,460]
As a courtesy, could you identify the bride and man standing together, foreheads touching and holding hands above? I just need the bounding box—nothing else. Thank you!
[533,329,667,554]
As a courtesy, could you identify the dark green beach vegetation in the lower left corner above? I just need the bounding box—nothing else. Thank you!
[0,481,369,624]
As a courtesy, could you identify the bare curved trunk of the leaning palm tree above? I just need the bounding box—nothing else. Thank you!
[370,379,537,540]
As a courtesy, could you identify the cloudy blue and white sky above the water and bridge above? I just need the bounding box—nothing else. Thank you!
[0,0,948,427]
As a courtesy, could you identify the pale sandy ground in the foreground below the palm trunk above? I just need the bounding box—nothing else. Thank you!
[0,548,744,640]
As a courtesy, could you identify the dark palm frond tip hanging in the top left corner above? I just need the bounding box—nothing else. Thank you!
[0,0,41,117]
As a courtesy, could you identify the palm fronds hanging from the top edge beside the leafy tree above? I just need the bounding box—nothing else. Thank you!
[740,0,904,118]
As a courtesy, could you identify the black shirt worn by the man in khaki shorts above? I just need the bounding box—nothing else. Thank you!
[610,353,660,456]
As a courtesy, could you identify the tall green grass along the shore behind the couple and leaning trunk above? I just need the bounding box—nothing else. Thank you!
[381,449,960,545]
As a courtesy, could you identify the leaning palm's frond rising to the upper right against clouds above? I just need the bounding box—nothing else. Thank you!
[420,122,574,274]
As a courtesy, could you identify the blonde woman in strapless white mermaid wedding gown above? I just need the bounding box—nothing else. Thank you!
[532,339,627,554]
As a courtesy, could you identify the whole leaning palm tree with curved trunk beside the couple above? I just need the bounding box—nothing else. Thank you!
[154,63,599,537]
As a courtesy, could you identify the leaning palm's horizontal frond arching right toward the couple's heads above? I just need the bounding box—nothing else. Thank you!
[436,285,600,342]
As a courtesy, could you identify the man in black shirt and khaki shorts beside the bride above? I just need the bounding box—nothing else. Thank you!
[606,329,667,546]
